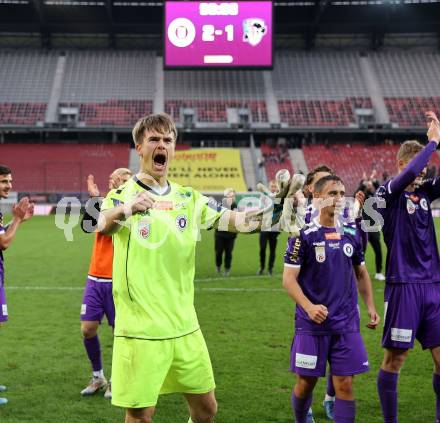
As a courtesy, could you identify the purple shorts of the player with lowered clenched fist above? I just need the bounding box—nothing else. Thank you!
[290,332,369,377]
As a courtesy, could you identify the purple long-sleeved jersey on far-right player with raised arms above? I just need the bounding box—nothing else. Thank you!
[376,141,440,283]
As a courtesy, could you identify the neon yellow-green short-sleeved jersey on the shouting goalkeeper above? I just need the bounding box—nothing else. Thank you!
[101,177,223,339]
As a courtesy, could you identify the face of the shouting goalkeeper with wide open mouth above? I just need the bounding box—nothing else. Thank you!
[136,131,176,180]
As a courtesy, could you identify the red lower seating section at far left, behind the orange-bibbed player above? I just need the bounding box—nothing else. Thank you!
[0,144,130,193]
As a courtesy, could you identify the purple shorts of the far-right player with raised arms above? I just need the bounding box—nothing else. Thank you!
[382,283,440,349]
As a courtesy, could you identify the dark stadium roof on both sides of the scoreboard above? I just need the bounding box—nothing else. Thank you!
[0,0,440,44]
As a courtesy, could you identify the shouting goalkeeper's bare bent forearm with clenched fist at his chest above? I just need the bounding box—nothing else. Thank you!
[98,192,155,235]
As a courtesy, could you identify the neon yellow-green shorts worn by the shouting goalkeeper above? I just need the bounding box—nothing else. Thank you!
[112,330,215,408]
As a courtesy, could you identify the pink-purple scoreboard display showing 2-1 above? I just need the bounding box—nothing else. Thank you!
[164,1,273,69]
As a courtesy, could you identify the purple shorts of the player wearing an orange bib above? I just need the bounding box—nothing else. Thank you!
[81,278,115,326]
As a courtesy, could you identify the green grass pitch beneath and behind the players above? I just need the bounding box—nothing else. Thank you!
[0,217,440,423]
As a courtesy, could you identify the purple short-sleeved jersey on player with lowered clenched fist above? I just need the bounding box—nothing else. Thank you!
[284,220,364,335]
